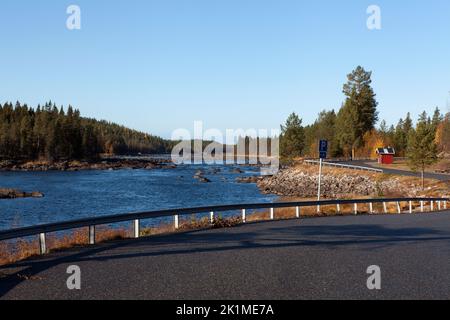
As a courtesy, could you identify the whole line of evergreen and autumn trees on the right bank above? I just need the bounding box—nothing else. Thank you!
[280,67,450,158]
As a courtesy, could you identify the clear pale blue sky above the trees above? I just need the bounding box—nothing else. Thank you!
[0,0,450,137]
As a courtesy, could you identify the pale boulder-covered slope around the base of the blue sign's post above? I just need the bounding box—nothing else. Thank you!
[257,168,403,198]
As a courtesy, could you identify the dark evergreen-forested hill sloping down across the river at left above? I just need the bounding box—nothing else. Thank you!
[0,102,173,160]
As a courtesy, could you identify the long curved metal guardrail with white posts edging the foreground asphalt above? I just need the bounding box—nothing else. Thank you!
[0,198,450,254]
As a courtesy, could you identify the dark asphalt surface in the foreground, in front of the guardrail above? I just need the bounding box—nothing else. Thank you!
[0,212,450,300]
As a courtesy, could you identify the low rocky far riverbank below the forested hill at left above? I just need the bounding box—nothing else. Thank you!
[0,158,175,171]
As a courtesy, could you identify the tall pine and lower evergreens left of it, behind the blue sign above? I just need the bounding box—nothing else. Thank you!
[280,66,378,157]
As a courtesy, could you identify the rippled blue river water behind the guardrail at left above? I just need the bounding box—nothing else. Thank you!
[0,165,275,230]
